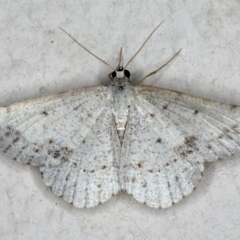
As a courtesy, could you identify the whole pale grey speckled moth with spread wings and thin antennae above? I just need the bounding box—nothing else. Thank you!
[0,23,240,208]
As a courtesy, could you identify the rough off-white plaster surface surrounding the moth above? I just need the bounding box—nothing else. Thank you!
[0,0,240,240]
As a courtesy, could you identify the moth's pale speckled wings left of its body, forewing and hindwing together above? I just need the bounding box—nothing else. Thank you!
[0,86,120,207]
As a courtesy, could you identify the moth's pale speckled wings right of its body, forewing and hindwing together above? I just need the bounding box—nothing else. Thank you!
[120,86,240,208]
